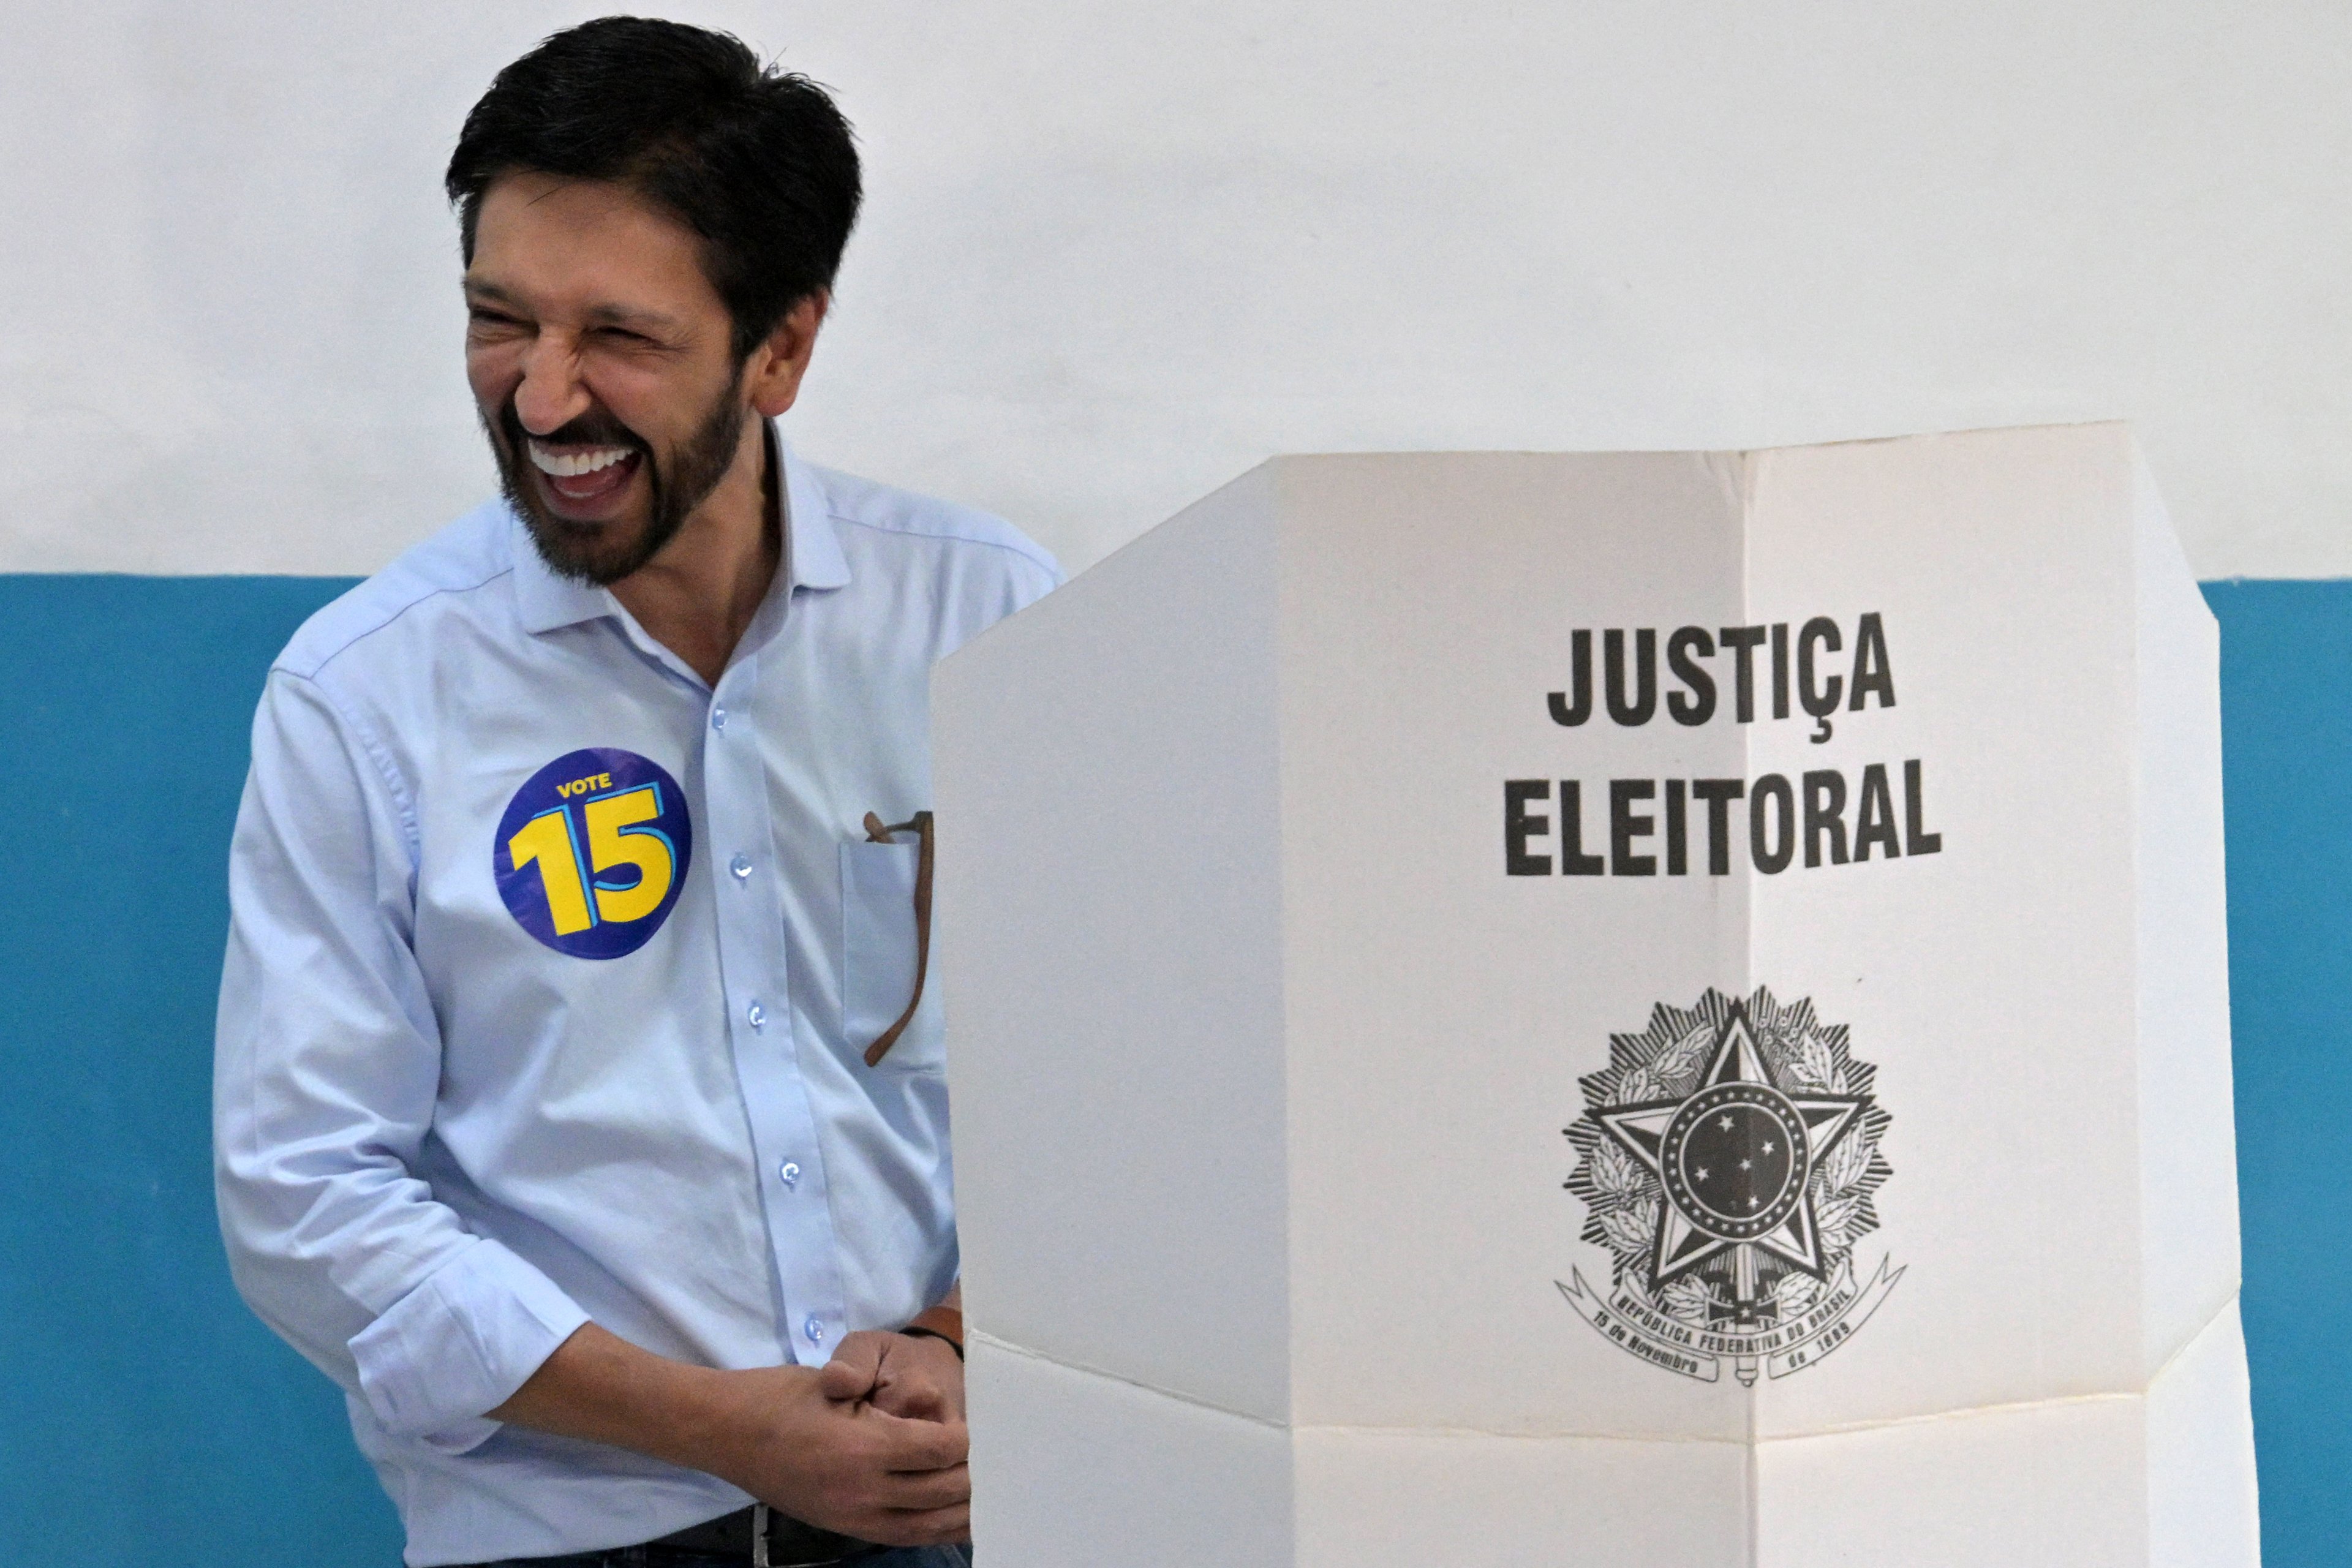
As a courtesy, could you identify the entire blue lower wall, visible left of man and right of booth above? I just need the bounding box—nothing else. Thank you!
[0,576,2352,1568]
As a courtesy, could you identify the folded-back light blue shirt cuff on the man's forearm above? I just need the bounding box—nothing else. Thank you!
[350,1242,588,1453]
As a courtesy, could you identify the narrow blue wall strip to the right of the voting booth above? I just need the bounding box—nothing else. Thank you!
[2206,581,2352,1568]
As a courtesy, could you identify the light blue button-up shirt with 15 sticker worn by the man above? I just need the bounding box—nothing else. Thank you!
[214,442,1058,1566]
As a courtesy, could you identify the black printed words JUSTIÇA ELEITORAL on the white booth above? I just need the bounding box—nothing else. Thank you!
[1503,611,1943,877]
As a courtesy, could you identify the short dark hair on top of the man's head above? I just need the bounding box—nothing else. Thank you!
[442,17,861,362]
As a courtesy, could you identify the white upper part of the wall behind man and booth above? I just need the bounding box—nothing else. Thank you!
[0,0,2352,576]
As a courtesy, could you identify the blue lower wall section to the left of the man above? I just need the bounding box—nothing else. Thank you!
[0,576,400,1568]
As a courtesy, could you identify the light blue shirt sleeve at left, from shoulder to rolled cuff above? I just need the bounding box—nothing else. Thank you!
[214,670,588,1450]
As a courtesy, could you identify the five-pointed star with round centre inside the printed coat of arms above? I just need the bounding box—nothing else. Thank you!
[1593,1004,1865,1295]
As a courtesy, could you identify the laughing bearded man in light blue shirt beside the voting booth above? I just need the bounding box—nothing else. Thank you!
[214,19,1058,1568]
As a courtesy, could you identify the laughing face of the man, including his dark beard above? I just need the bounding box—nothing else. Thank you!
[466,174,753,583]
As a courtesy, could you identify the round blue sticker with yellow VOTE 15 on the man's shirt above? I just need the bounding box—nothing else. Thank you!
[492,745,694,959]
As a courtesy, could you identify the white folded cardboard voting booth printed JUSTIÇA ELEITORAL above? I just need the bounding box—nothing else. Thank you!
[933,426,2256,1568]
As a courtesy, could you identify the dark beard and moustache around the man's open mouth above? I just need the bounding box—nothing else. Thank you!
[482,369,750,588]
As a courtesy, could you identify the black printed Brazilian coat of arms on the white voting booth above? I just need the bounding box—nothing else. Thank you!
[1557,987,1903,1385]
